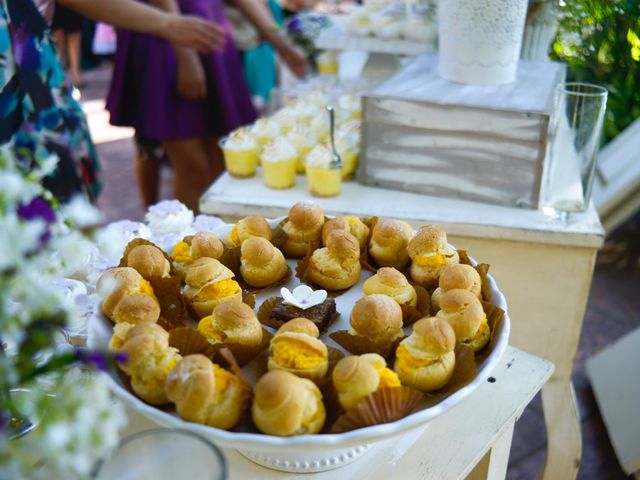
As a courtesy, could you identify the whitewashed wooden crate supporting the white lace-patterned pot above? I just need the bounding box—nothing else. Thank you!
[360,54,566,208]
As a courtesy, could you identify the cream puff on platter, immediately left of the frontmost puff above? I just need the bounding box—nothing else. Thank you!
[165,354,250,430]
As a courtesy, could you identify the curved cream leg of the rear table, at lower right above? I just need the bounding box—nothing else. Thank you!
[542,378,582,480]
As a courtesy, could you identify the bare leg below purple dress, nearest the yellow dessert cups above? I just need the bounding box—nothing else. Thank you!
[162,138,214,212]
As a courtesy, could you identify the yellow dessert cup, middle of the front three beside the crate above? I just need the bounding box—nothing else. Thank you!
[260,137,298,189]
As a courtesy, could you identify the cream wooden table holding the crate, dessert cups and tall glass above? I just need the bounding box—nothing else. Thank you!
[200,172,604,480]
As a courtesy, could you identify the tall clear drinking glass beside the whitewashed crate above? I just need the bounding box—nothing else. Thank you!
[542,82,607,221]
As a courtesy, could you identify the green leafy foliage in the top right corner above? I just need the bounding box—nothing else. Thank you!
[551,0,640,142]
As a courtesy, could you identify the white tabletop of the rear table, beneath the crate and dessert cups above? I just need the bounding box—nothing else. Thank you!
[200,169,604,248]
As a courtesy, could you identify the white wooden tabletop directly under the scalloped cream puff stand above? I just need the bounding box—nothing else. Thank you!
[124,347,554,480]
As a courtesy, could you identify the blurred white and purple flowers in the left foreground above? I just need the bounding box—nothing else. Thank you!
[0,148,126,479]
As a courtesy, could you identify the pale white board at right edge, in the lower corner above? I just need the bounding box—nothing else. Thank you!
[587,328,640,475]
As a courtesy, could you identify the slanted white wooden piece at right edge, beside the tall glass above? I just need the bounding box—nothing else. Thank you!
[593,119,640,232]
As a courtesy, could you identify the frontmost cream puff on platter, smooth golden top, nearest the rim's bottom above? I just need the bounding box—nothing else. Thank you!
[251,370,326,436]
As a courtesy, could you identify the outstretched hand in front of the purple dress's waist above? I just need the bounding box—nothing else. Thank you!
[162,14,226,53]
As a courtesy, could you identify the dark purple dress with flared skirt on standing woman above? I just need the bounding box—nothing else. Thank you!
[107,0,256,140]
